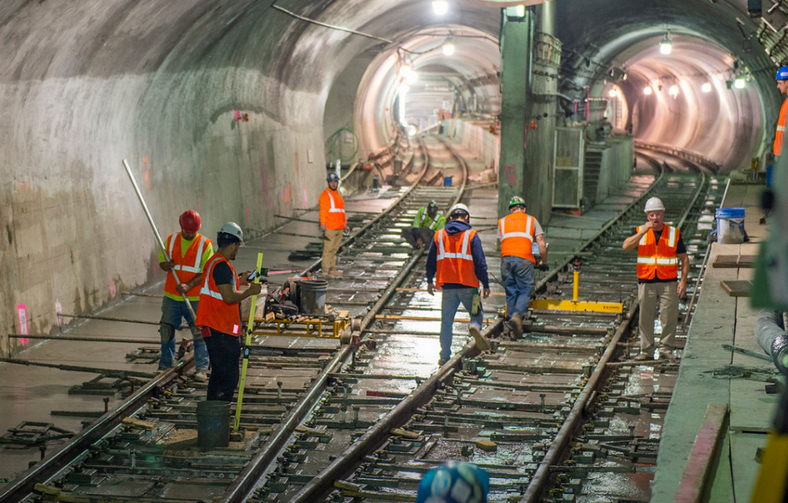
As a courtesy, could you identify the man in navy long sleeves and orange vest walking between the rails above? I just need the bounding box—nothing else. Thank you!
[427,204,490,365]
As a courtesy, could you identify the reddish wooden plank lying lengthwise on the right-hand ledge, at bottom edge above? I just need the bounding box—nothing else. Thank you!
[673,403,728,503]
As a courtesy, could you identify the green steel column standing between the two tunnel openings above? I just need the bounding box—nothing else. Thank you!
[498,9,534,220]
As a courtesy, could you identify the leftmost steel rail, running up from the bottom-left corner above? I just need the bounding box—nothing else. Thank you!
[0,357,194,503]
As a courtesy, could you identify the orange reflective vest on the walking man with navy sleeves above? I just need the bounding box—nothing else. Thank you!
[434,229,479,288]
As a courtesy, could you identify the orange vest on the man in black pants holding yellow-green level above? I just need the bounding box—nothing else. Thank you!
[196,253,241,337]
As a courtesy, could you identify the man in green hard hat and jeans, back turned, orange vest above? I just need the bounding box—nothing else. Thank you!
[498,196,547,338]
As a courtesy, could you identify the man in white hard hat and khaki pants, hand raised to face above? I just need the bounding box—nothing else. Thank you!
[623,197,689,361]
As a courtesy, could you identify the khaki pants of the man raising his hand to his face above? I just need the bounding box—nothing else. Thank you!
[638,281,679,353]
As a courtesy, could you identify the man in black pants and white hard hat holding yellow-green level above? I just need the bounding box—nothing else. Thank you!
[197,222,262,402]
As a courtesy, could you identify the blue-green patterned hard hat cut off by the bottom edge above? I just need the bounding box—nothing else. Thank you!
[416,461,490,503]
